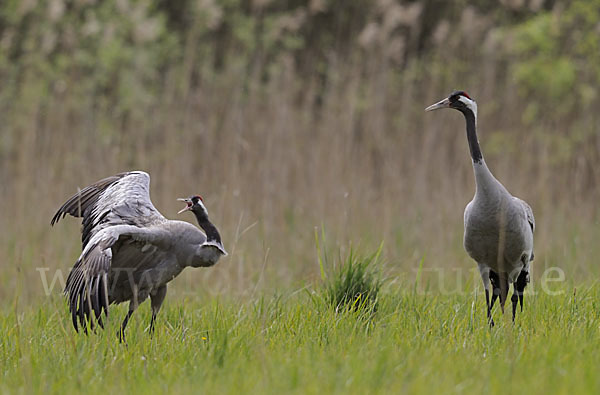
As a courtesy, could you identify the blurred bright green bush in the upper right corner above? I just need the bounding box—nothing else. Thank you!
[512,0,600,120]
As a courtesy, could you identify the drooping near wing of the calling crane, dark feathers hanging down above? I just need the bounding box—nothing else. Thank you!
[65,225,170,330]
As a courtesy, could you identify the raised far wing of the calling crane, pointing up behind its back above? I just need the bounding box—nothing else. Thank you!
[50,171,165,249]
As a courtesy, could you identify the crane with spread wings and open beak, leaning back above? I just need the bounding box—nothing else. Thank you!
[51,171,227,340]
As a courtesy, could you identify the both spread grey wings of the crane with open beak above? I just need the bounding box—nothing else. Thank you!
[51,171,170,332]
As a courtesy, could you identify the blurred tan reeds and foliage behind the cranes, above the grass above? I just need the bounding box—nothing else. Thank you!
[0,0,600,290]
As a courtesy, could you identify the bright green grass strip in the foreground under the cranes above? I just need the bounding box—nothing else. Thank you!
[0,285,600,394]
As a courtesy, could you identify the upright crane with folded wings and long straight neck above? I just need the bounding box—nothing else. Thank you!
[425,91,535,326]
